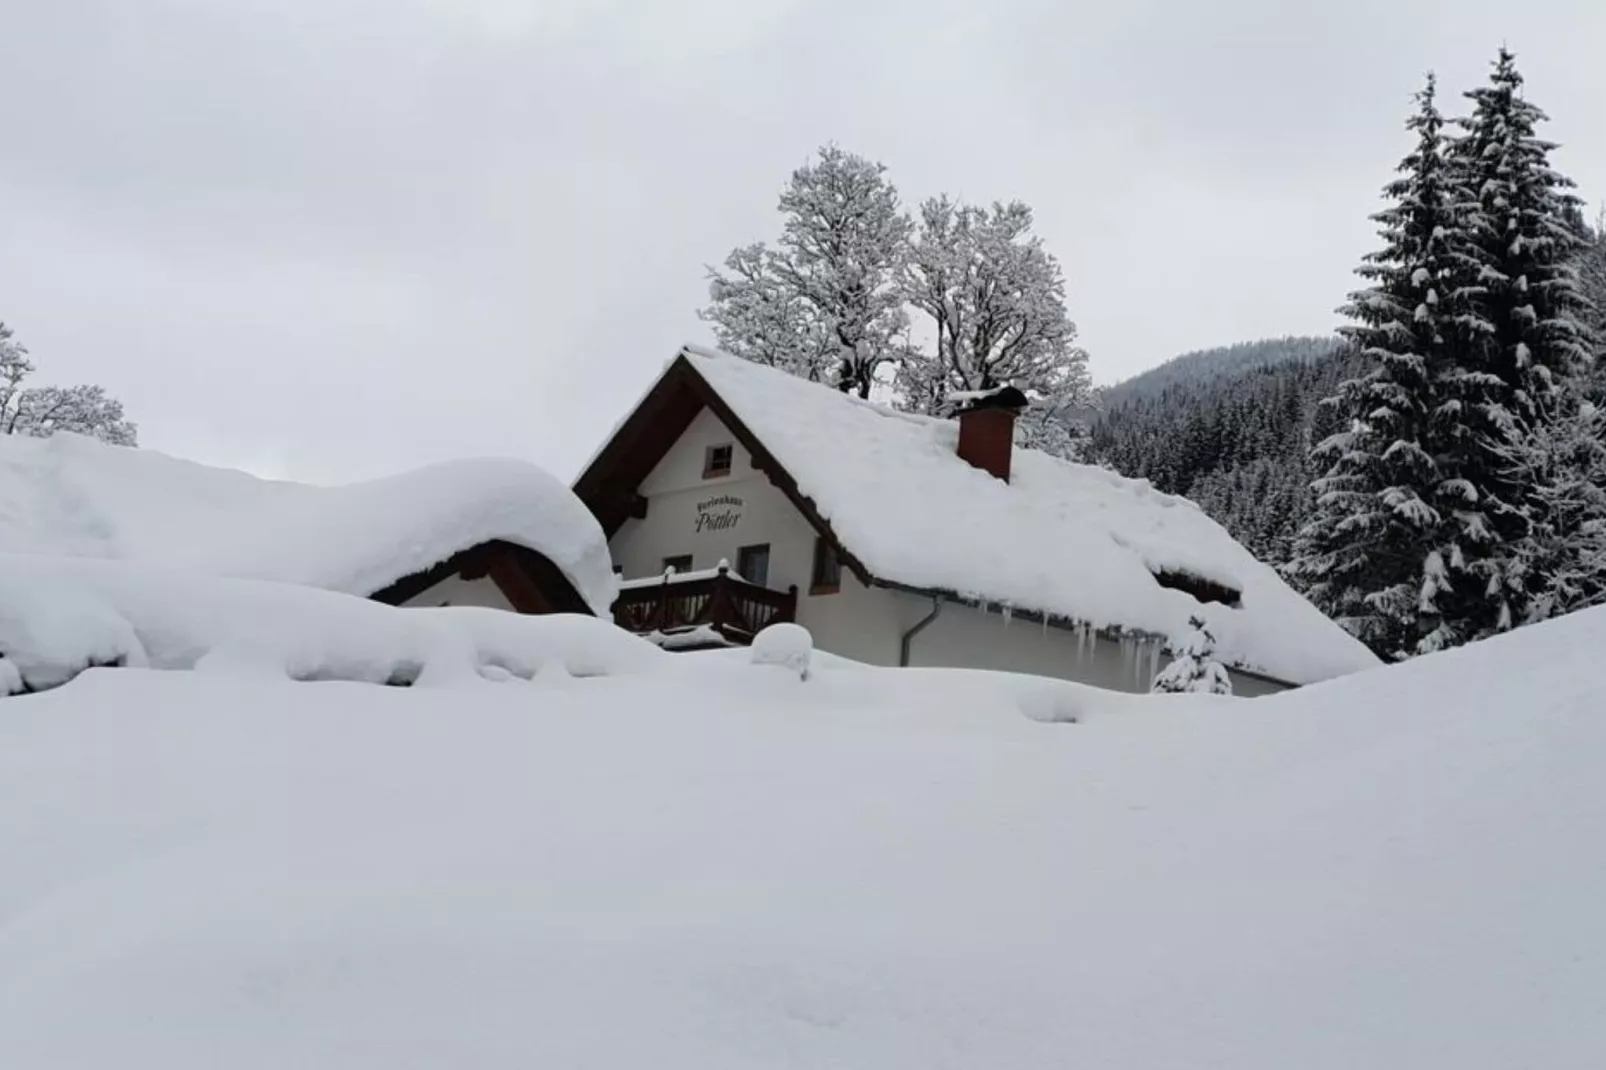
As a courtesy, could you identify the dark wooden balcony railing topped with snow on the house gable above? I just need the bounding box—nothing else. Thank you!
[613,566,798,644]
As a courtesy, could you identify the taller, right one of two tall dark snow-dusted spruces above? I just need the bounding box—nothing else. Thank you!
[1418,48,1593,651]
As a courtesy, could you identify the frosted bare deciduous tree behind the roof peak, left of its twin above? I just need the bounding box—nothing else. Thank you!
[699,145,911,397]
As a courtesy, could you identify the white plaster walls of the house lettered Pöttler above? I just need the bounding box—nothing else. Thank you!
[610,410,1280,696]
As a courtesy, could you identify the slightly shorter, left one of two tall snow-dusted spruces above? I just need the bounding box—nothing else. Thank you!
[1286,76,1476,657]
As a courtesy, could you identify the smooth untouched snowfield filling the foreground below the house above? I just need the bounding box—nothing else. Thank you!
[0,611,1606,1070]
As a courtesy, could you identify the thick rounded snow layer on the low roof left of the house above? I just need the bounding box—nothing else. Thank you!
[0,434,615,614]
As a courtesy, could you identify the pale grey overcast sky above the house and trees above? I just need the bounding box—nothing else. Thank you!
[0,0,1606,482]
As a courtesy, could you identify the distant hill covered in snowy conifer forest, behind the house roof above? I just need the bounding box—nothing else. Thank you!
[1089,337,1362,566]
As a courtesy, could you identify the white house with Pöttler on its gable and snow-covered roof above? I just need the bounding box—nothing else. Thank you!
[575,347,1376,694]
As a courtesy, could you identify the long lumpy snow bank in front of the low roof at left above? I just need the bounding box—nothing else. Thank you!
[0,554,668,694]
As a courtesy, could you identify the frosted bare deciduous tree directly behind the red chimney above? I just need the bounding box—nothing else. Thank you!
[898,196,1092,456]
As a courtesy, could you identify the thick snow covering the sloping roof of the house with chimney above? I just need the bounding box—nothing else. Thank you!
[684,347,1378,683]
